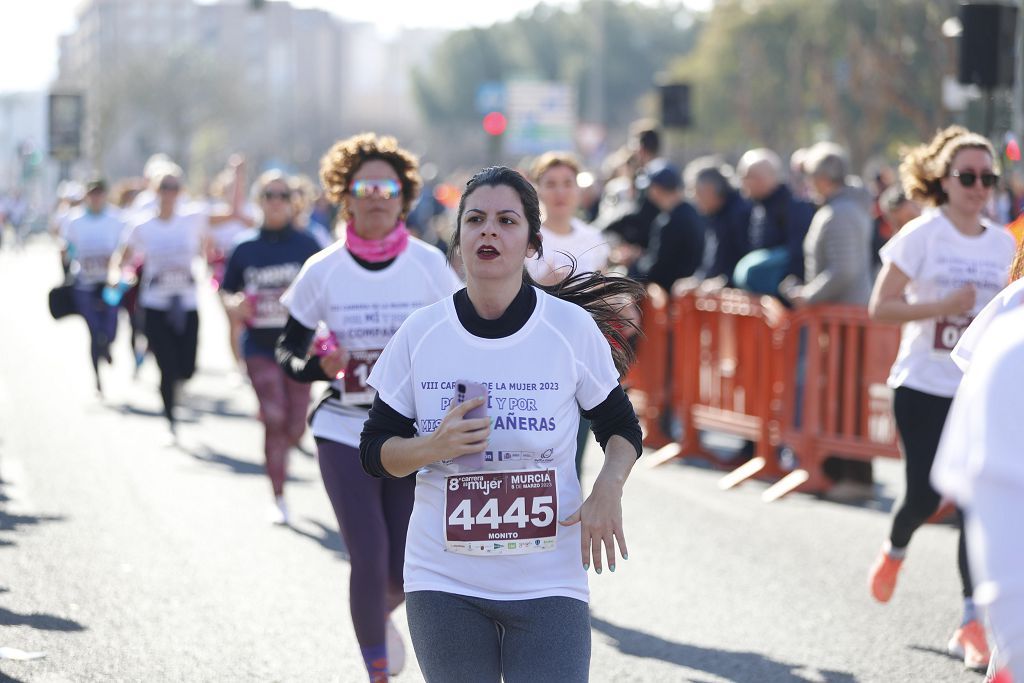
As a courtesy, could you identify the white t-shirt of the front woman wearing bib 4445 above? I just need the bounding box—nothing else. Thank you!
[370,290,618,601]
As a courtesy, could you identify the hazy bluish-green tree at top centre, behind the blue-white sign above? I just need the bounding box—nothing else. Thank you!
[413,0,699,136]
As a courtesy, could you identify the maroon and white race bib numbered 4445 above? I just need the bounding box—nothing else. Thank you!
[444,469,558,557]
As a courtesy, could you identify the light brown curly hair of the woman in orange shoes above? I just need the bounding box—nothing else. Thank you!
[899,126,997,206]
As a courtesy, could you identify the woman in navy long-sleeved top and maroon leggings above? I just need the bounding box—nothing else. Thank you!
[220,170,321,524]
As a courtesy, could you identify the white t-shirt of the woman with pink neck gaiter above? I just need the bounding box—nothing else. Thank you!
[281,238,462,447]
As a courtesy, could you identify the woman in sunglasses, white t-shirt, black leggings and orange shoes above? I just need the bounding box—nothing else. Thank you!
[868,126,1014,670]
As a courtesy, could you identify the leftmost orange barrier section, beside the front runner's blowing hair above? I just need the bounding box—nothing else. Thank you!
[624,288,672,449]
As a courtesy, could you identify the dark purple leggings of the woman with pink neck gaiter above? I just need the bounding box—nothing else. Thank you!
[316,438,416,667]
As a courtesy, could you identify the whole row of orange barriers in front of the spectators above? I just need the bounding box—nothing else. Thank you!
[629,290,899,500]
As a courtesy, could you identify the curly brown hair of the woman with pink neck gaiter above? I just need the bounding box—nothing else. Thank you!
[321,133,423,219]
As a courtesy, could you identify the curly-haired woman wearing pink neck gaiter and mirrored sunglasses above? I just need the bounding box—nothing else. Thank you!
[276,133,461,681]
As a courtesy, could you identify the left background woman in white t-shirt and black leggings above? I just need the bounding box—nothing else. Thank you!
[119,164,206,439]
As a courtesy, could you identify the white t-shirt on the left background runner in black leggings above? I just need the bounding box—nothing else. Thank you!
[125,213,206,310]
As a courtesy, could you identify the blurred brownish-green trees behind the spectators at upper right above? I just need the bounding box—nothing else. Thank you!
[671,0,956,163]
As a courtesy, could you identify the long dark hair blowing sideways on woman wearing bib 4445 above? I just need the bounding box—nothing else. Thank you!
[449,166,645,375]
